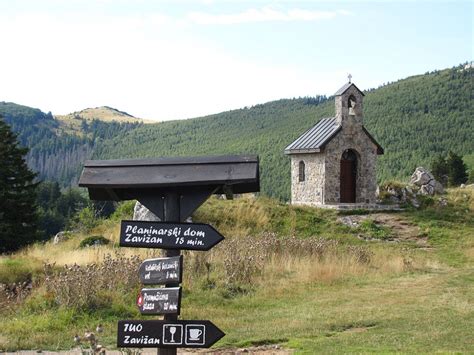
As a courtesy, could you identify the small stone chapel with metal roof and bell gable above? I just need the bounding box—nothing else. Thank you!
[285,80,383,207]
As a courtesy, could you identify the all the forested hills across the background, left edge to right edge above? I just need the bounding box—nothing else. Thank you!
[0,66,474,199]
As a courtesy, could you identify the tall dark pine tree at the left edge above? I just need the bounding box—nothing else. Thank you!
[0,117,39,253]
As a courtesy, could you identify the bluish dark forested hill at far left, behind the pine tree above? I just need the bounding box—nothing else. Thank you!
[0,102,141,186]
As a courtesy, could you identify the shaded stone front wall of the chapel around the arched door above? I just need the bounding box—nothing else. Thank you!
[323,125,377,204]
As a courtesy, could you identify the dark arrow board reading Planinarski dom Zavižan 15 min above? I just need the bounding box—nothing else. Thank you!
[120,221,224,250]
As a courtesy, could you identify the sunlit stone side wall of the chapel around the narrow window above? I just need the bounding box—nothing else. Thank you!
[291,153,325,205]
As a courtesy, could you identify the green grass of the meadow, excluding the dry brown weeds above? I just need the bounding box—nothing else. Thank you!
[0,189,474,354]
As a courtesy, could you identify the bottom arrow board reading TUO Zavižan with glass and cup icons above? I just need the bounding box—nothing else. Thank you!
[117,320,225,348]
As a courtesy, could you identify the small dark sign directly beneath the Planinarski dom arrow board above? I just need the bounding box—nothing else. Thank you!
[138,255,183,285]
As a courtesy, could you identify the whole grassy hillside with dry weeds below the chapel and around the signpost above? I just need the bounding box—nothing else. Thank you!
[0,189,474,354]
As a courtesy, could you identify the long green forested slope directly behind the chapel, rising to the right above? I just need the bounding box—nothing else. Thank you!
[94,66,474,199]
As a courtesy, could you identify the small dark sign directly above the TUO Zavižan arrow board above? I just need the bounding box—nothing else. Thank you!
[137,287,181,314]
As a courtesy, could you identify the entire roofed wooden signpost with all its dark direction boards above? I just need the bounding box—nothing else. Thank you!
[79,156,260,355]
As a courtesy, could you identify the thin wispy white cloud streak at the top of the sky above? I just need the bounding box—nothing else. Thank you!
[187,7,350,25]
